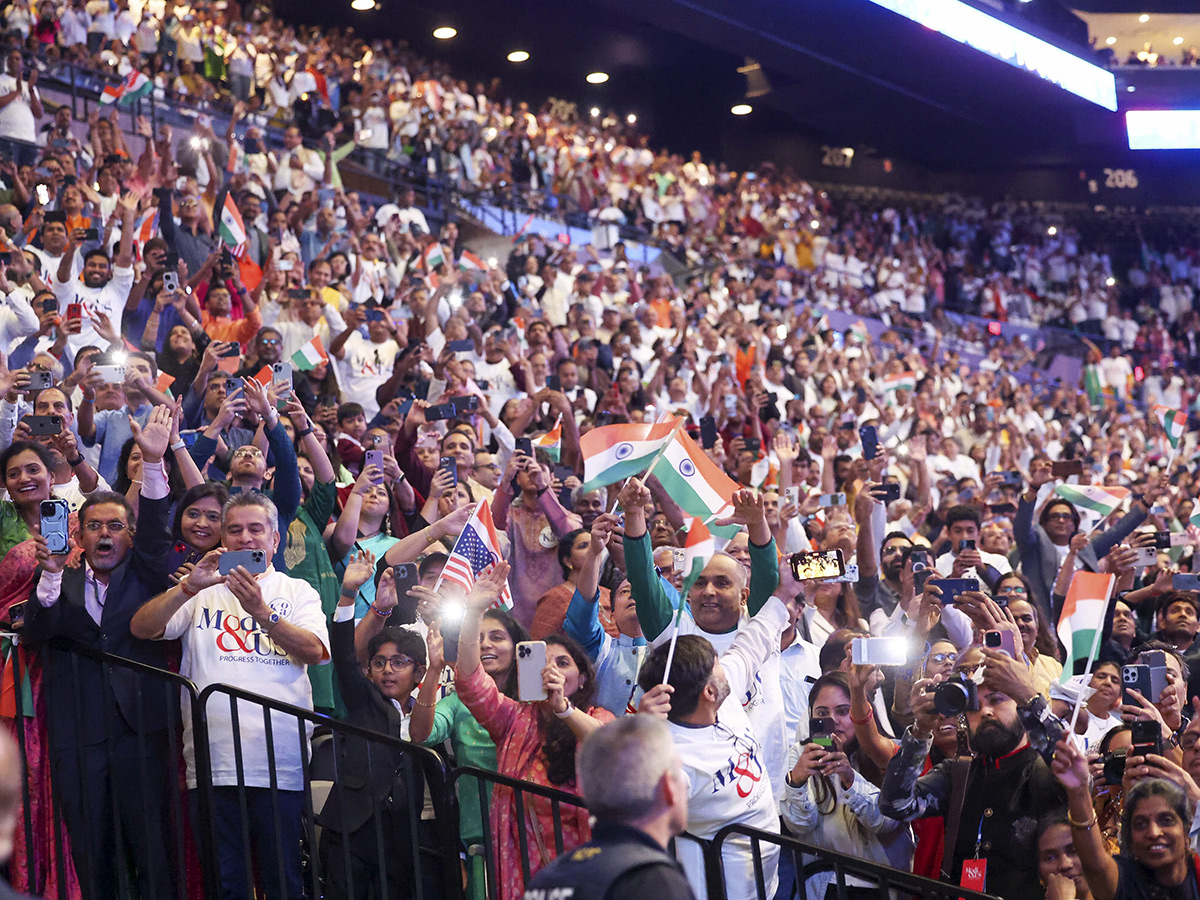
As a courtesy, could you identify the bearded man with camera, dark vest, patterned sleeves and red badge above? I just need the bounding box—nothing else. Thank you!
[880,648,1064,900]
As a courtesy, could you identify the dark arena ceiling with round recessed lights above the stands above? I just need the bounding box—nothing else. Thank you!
[278,0,1200,172]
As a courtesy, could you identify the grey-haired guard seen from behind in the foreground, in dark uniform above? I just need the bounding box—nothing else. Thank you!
[524,714,696,900]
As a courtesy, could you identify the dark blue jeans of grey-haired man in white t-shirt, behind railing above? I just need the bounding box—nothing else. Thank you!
[192,787,304,900]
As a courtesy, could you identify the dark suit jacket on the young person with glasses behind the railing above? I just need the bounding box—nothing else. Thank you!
[317,620,425,846]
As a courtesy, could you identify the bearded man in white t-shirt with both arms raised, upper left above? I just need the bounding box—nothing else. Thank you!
[50,197,137,356]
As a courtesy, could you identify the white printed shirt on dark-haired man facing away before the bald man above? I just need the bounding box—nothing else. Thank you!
[668,596,787,900]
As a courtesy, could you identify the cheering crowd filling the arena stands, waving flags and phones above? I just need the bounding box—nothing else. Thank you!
[0,0,1200,900]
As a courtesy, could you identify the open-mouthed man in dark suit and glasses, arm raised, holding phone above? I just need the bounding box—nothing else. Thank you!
[22,407,179,899]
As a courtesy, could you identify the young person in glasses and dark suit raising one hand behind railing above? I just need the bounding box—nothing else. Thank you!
[317,553,426,899]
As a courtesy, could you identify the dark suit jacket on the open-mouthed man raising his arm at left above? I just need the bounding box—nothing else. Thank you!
[22,497,179,750]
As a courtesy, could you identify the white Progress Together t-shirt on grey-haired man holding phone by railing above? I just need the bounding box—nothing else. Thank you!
[163,568,329,791]
